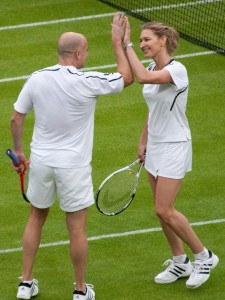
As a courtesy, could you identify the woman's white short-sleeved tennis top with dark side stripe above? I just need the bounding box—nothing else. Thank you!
[143,60,191,142]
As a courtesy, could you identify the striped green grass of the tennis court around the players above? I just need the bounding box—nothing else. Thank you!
[0,0,225,300]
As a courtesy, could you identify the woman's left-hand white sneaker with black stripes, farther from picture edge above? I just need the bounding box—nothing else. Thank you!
[155,258,193,284]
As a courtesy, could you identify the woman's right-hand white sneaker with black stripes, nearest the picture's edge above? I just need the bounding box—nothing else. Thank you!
[186,250,219,289]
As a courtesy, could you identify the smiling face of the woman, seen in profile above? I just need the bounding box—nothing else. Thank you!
[140,29,164,58]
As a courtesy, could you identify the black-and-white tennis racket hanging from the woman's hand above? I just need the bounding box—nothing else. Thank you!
[95,159,143,216]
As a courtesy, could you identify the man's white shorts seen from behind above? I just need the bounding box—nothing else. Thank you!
[27,162,94,212]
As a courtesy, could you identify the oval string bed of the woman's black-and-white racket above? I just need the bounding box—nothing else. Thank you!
[98,169,137,214]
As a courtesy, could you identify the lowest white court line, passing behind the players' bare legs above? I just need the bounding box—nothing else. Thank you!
[0,219,225,254]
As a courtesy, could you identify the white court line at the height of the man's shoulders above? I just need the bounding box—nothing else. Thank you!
[0,51,216,83]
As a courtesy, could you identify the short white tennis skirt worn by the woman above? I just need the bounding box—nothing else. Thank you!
[145,140,192,179]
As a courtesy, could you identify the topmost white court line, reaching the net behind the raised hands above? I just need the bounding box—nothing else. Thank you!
[0,0,223,31]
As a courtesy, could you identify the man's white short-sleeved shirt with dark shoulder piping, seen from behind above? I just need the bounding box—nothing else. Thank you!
[14,65,124,168]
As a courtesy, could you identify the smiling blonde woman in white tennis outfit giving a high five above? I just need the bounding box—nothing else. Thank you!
[113,15,219,288]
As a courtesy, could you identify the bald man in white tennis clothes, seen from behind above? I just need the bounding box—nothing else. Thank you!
[11,18,133,300]
